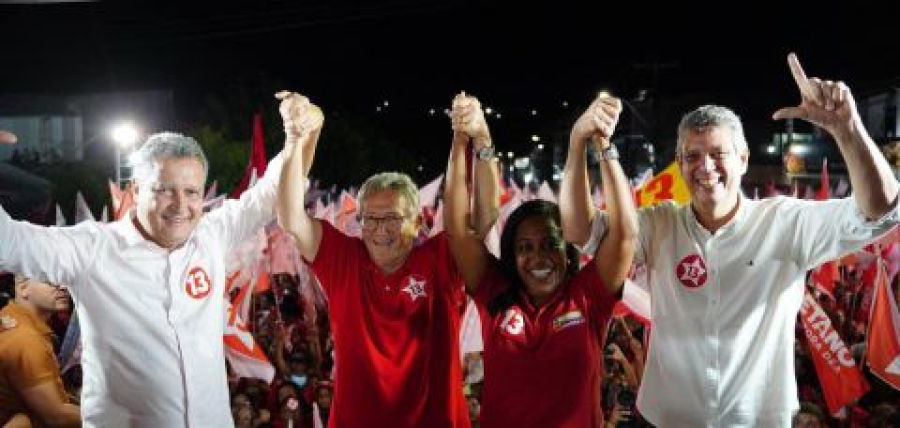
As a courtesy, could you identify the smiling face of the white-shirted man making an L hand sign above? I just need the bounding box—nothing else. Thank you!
[678,126,748,220]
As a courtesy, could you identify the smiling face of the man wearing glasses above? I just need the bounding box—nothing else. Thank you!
[360,189,420,272]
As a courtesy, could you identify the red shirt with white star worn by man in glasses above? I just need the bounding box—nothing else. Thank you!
[310,222,469,427]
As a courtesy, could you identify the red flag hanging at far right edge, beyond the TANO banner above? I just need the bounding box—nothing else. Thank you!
[866,261,900,390]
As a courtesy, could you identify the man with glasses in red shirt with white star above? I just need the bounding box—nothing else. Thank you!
[278,93,469,427]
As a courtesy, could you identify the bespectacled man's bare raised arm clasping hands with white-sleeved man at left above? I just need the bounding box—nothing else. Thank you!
[276,92,324,260]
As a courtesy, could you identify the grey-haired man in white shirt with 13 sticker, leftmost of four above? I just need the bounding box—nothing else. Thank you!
[0,93,322,428]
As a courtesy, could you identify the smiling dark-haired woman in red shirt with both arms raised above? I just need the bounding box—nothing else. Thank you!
[444,95,637,427]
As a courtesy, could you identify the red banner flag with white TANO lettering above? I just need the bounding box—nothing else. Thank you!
[800,291,869,415]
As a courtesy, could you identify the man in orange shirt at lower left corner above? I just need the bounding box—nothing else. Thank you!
[0,275,81,427]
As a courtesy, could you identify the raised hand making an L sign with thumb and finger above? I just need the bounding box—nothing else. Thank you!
[772,52,859,135]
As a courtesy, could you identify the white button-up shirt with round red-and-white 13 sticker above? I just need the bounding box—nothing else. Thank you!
[0,156,281,428]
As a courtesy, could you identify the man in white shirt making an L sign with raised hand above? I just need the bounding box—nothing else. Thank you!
[560,54,898,427]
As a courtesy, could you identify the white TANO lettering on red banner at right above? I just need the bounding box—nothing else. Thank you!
[800,293,856,371]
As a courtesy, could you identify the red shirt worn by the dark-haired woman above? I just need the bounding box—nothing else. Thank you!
[474,262,617,427]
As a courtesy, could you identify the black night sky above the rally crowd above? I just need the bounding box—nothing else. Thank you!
[0,0,900,169]
